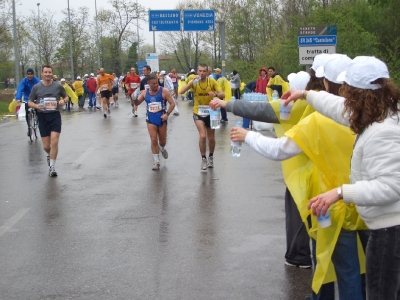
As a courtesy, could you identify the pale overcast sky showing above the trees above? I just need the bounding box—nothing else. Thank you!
[16,0,179,45]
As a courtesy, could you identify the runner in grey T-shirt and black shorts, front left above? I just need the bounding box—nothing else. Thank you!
[28,65,68,177]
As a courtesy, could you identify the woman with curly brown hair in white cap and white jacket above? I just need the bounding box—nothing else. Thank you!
[282,56,400,300]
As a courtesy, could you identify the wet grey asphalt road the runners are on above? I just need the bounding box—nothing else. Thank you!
[0,94,311,300]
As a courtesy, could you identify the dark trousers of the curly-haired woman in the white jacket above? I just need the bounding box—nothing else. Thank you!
[366,225,400,300]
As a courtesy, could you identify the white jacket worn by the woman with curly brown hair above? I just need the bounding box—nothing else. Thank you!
[307,91,400,229]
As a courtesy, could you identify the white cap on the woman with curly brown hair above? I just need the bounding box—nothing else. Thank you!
[336,56,390,90]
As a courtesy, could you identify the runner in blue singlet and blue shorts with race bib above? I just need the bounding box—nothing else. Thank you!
[136,74,175,170]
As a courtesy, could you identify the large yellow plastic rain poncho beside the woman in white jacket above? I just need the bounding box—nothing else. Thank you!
[284,111,368,293]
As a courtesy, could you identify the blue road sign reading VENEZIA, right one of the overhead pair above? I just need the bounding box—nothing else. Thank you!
[183,10,215,31]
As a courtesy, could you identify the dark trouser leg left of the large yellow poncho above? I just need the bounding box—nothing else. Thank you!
[285,188,311,266]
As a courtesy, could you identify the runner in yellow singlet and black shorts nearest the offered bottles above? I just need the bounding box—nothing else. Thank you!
[179,64,225,170]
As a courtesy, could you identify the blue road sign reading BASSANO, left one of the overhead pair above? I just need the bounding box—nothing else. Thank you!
[149,10,181,31]
